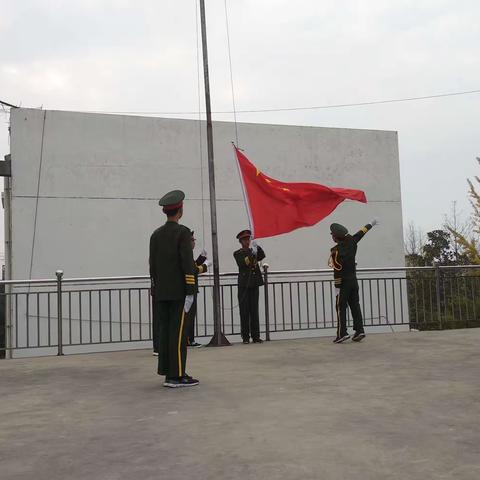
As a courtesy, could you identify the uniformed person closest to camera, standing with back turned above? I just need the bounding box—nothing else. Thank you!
[149,190,199,388]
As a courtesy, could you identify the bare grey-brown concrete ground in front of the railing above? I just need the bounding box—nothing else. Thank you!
[0,329,480,480]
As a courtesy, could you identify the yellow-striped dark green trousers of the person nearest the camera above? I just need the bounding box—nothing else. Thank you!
[153,300,187,378]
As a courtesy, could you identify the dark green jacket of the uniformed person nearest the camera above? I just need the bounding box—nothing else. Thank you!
[149,221,197,300]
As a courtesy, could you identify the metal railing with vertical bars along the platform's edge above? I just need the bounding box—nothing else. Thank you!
[0,265,480,356]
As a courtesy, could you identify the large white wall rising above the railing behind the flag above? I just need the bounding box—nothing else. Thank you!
[11,105,404,279]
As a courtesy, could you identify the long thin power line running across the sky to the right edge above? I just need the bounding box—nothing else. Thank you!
[79,89,480,115]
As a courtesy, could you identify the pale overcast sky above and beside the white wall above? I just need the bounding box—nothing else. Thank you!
[0,0,480,258]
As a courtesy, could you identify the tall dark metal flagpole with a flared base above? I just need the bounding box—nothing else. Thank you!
[200,0,230,347]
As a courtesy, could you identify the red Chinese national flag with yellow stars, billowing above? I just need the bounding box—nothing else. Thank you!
[234,146,367,238]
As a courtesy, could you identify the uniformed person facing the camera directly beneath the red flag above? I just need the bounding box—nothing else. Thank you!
[233,230,265,344]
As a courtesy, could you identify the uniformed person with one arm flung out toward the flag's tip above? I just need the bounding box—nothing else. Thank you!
[328,220,378,343]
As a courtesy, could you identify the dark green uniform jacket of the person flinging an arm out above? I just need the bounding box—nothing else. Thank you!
[328,224,372,287]
